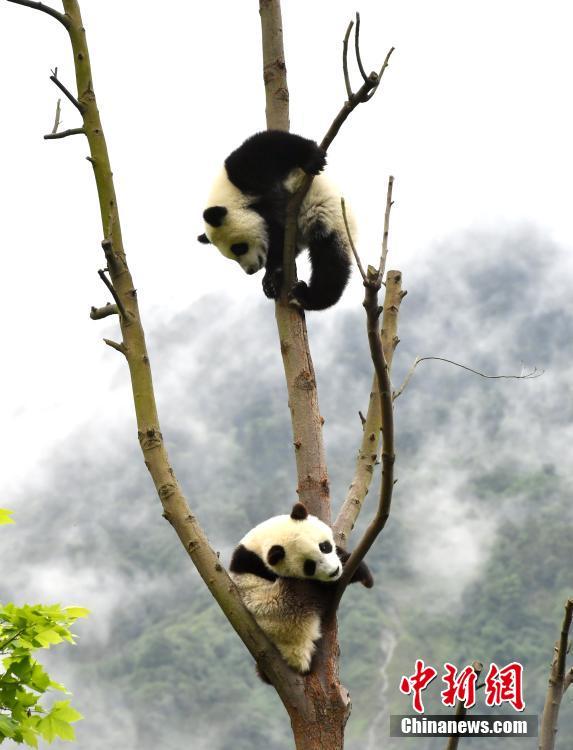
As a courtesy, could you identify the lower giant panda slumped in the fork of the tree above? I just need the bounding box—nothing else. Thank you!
[230,503,373,681]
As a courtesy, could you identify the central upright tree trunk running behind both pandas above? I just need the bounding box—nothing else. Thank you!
[259,0,350,750]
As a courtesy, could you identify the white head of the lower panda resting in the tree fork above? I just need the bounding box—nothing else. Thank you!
[241,505,342,582]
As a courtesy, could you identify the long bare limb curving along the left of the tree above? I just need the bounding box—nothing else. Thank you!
[11,0,305,710]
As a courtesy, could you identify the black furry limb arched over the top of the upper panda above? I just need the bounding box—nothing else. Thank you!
[225,130,326,195]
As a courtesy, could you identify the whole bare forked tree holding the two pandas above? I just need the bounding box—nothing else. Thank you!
[8,0,404,748]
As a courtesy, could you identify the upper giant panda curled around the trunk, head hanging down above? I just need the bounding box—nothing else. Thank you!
[197,130,355,310]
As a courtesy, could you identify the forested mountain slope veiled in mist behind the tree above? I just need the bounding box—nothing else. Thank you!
[0,228,573,750]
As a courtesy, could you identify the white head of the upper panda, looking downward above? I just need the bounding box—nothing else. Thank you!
[199,170,268,275]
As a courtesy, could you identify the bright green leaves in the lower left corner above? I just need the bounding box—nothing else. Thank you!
[0,604,88,747]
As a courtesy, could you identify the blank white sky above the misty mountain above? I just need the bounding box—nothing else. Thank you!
[0,0,573,490]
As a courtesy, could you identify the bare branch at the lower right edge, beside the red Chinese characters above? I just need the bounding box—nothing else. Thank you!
[539,599,573,750]
